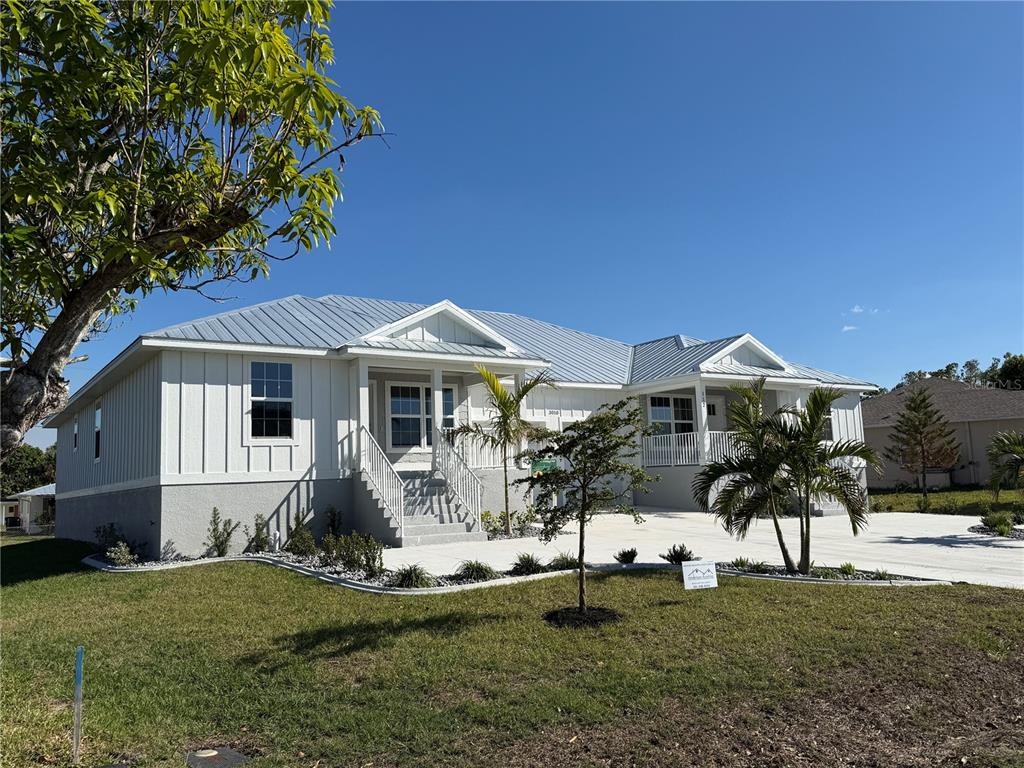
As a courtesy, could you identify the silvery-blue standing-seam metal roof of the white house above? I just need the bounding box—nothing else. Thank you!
[138,295,871,387]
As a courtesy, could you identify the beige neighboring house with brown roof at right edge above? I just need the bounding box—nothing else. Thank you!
[861,378,1024,488]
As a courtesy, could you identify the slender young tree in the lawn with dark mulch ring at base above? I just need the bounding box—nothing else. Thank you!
[516,398,656,613]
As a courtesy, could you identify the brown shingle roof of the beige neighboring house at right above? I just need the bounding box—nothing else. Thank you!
[861,378,1024,427]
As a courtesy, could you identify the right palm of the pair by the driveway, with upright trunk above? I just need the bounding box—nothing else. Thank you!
[778,387,881,574]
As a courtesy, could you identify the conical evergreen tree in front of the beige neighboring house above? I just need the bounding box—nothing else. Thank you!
[884,385,959,508]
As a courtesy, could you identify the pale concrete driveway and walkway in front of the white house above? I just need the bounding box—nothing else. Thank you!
[384,508,1024,589]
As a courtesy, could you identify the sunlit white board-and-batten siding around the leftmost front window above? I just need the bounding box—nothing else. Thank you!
[161,350,355,483]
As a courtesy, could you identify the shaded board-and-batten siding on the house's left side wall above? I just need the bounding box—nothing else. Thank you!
[56,355,160,495]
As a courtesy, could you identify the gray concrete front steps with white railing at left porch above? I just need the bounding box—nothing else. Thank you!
[360,467,487,547]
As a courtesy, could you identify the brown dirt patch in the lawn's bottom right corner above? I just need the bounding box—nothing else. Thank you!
[485,654,1024,768]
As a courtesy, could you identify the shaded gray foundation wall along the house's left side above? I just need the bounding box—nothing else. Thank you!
[54,485,161,557]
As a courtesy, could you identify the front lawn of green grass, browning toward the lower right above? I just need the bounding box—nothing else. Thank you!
[6,540,1024,768]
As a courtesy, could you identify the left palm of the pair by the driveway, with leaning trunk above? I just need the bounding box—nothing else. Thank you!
[693,378,797,573]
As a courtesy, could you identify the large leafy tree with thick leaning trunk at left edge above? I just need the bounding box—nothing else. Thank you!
[0,0,382,458]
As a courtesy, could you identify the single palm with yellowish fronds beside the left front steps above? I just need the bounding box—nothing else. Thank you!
[455,366,554,535]
